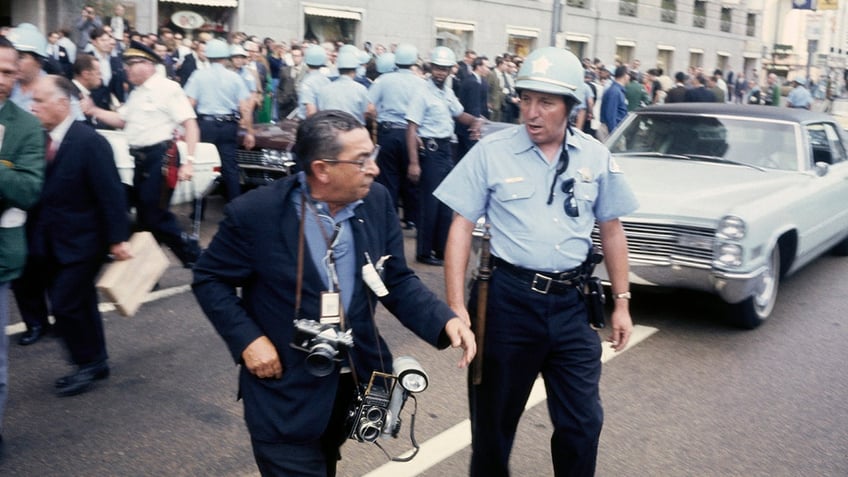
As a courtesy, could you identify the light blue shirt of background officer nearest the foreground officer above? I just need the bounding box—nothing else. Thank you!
[406,80,464,139]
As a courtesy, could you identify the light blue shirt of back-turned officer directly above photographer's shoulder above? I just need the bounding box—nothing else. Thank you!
[368,69,426,125]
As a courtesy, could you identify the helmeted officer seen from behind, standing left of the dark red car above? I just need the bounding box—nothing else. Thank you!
[185,39,255,200]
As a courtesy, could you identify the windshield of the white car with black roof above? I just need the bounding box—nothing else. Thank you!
[609,114,798,170]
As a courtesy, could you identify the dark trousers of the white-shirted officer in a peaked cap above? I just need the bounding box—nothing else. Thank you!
[130,141,186,261]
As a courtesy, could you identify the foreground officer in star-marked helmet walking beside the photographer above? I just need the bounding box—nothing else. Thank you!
[435,47,637,477]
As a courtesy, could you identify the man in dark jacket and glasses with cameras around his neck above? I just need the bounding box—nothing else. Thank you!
[192,110,476,477]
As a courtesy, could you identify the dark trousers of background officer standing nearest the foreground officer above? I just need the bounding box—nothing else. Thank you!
[417,138,453,258]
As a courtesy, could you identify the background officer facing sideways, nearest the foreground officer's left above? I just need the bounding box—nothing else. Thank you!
[406,46,482,265]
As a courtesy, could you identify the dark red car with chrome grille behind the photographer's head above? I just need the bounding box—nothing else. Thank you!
[236,119,298,189]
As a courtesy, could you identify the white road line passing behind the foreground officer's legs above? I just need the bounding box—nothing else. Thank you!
[364,325,659,477]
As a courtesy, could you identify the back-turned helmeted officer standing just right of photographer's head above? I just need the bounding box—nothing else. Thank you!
[368,43,425,227]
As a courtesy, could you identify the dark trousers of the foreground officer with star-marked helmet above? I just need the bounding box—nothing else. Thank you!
[468,268,603,477]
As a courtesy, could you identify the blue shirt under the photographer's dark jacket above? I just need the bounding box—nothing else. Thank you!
[292,171,362,310]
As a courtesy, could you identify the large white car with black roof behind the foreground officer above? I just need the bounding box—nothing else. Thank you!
[606,103,848,328]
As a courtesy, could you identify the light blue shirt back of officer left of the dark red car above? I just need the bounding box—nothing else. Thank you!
[184,63,250,115]
